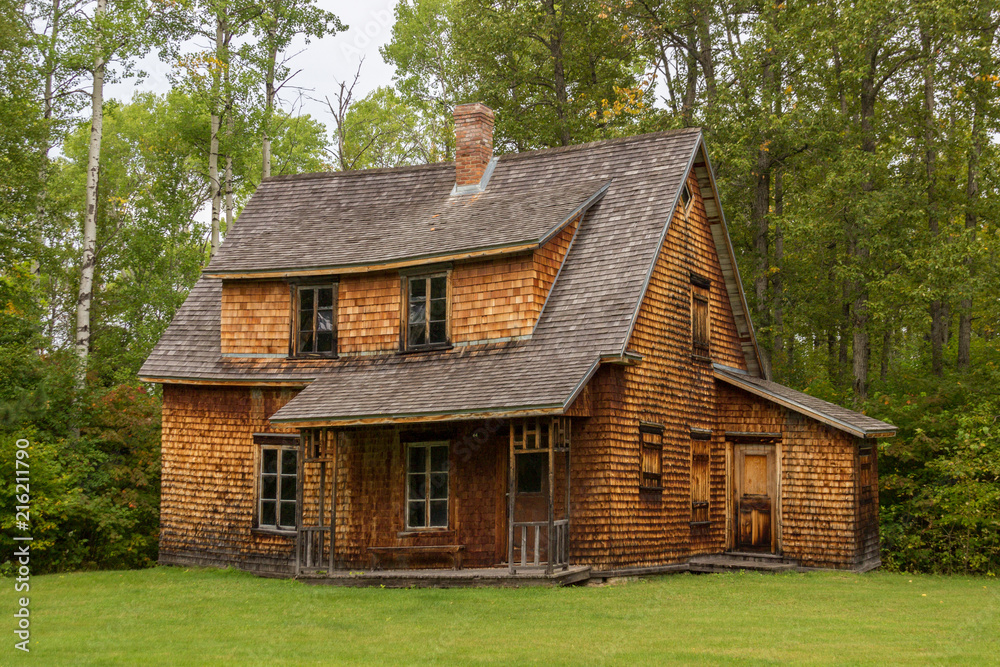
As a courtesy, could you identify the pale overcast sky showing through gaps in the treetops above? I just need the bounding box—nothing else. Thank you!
[106,0,396,130]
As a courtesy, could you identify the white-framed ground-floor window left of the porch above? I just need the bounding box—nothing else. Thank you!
[257,438,299,530]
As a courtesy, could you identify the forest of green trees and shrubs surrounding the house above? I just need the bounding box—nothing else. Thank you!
[0,0,1000,575]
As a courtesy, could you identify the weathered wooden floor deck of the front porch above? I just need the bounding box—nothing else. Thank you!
[297,565,590,588]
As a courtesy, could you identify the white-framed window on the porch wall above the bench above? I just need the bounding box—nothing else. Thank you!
[406,442,450,529]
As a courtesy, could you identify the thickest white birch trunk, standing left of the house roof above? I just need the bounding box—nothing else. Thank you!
[76,0,108,387]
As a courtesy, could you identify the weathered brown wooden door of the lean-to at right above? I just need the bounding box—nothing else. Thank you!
[733,444,779,553]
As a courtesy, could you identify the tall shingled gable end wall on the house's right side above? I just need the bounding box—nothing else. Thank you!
[573,168,746,569]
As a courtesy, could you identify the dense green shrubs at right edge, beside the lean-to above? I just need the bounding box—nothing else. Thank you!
[872,361,1000,575]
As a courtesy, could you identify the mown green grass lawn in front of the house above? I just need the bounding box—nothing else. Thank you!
[0,568,1000,665]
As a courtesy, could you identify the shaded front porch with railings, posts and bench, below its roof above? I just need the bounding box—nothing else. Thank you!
[294,417,572,586]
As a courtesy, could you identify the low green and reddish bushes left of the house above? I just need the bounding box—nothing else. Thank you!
[0,385,160,573]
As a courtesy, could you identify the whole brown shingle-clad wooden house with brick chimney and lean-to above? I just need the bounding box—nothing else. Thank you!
[141,104,895,577]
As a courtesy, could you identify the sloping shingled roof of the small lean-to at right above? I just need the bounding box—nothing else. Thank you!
[714,364,896,438]
